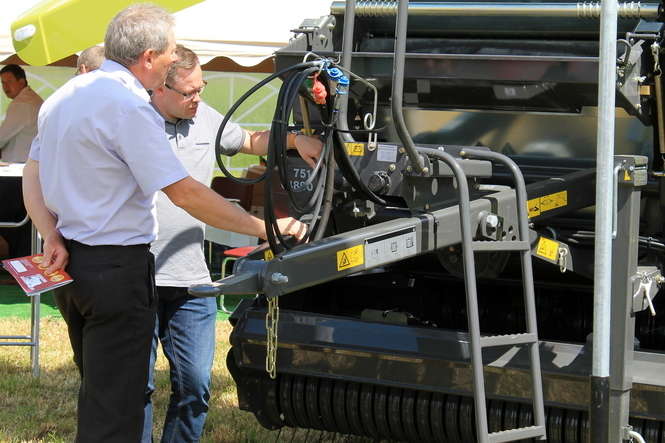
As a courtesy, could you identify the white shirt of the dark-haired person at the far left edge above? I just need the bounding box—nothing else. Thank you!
[0,86,44,163]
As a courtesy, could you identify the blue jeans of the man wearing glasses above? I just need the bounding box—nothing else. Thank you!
[142,286,217,443]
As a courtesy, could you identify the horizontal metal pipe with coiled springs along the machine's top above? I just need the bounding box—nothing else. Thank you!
[330,0,659,20]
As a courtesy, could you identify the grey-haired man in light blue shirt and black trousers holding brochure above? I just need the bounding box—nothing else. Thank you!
[23,3,304,443]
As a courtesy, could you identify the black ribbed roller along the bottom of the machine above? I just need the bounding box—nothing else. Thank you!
[249,374,665,443]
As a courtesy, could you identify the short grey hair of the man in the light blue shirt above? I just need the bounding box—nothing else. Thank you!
[104,3,175,66]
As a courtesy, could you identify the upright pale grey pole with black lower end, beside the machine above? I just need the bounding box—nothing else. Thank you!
[590,1,618,441]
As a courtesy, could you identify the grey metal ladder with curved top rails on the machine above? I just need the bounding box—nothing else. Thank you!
[426,149,545,443]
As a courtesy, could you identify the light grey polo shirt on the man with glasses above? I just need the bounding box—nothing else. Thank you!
[151,102,246,287]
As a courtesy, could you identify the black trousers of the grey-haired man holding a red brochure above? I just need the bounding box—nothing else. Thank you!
[55,241,157,443]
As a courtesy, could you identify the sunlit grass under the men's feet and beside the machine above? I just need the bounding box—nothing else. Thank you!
[0,317,348,443]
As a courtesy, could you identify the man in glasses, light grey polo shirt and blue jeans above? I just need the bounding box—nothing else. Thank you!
[143,45,322,443]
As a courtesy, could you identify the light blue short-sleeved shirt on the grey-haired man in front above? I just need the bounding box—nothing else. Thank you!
[30,60,188,245]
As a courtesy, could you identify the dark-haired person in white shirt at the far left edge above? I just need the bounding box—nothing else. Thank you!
[0,65,44,163]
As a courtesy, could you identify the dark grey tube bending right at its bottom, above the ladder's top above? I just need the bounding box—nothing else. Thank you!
[390,0,424,174]
